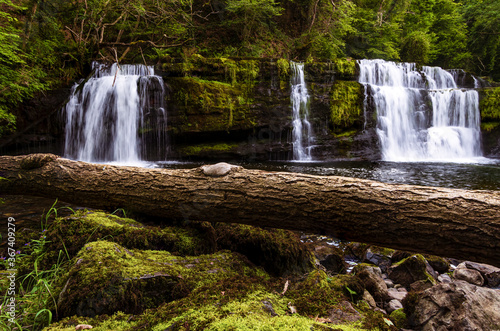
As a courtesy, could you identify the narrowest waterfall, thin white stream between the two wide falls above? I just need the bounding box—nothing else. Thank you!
[290,62,313,161]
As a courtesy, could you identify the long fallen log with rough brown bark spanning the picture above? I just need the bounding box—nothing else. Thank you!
[0,154,500,267]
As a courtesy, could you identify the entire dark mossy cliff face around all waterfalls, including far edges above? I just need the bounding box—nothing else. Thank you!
[4,55,500,161]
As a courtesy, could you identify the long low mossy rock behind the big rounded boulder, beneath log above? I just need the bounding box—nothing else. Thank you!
[19,210,216,274]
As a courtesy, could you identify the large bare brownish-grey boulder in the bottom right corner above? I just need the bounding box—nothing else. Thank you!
[409,280,500,331]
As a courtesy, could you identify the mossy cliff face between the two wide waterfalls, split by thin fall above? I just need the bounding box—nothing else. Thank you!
[161,57,379,161]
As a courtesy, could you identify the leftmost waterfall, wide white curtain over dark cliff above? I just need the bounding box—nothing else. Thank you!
[64,62,166,163]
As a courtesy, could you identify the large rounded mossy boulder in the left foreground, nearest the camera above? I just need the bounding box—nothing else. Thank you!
[58,241,265,317]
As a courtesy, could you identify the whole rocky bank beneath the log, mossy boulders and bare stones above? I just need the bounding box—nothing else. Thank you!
[2,201,500,330]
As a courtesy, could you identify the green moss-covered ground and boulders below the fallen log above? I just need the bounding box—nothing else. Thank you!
[2,210,398,330]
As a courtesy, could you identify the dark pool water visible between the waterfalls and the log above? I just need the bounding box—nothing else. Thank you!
[155,160,500,191]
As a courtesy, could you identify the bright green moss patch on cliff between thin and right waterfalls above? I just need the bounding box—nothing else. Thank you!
[330,80,363,130]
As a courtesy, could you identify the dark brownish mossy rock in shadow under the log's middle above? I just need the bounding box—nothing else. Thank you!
[214,223,315,276]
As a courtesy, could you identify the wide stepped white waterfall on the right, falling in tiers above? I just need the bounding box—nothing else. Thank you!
[358,60,482,162]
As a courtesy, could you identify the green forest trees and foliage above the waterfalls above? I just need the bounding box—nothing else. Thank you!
[0,0,500,136]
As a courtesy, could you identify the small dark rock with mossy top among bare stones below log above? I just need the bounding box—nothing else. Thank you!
[388,254,437,288]
